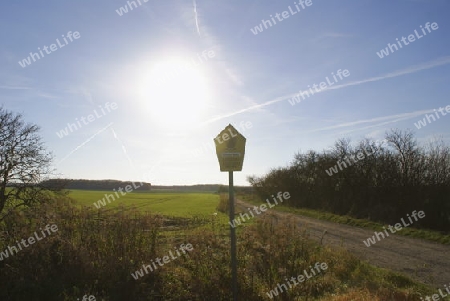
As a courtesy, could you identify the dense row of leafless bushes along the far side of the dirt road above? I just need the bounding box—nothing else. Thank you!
[248,130,450,232]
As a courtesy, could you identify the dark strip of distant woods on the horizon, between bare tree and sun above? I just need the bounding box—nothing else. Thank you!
[40,179,152,191]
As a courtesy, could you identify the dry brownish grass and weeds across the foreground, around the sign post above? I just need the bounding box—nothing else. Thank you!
[0,193,436,301]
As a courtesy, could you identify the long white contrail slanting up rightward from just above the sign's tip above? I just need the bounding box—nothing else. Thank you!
[201,56,450,126]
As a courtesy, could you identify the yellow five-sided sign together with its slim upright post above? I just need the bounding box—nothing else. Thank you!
[214,124,246,301]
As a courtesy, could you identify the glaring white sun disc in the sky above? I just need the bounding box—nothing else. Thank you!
[141,59,209,129]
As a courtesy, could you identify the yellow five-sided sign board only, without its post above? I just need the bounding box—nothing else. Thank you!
[214,124,247,171]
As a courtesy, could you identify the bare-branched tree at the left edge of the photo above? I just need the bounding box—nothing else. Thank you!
[0,107,52,220]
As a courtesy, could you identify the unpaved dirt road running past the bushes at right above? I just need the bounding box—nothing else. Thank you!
[236,200,450,288]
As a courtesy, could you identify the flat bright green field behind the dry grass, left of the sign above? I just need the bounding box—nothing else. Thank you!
[69,190,225,217]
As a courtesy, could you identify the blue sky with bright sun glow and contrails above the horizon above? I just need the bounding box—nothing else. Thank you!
[0,0,450,185]
